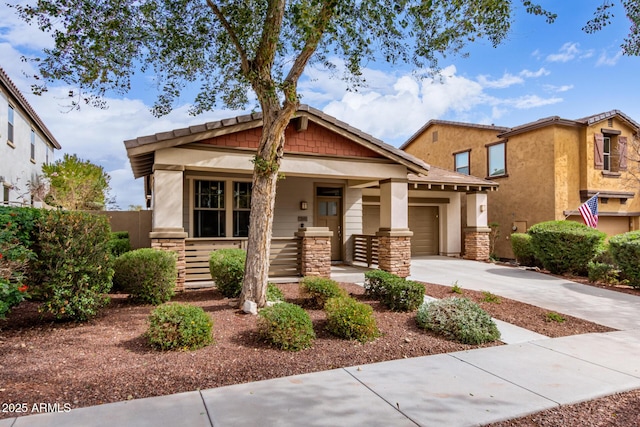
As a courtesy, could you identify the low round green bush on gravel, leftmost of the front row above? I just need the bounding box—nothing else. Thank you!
[145,303,213,350]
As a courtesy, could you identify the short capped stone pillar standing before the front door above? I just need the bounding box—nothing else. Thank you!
[296,227,333,278]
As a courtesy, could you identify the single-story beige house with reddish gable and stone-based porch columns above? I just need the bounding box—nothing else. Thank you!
[125,106,497,290]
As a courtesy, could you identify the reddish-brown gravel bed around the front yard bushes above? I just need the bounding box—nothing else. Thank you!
[0,284,640,426]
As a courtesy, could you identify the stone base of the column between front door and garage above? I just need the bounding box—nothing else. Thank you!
[376,228,413,277]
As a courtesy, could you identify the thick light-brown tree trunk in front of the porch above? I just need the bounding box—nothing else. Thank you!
[240,103,297,308]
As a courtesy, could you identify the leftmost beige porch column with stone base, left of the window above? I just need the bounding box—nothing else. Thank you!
[149,169,187,292]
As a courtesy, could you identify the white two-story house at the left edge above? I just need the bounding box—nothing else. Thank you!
[0,68,61,205]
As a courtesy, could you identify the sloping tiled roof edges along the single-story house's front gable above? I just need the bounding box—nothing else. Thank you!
[124,105,430,178]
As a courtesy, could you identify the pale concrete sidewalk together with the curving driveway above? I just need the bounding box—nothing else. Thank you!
[5,257,640,427]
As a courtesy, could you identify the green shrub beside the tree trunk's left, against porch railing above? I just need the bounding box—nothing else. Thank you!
[209,249,247,298]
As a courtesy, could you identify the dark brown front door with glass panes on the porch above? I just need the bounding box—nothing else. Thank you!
[315,187,342,261]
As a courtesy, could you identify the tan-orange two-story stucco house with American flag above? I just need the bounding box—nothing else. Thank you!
[401,110,640,258]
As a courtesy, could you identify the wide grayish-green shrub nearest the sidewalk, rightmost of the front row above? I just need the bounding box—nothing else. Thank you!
[416,297,500,344]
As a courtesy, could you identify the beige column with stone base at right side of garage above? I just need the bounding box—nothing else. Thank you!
[464,191,491,261]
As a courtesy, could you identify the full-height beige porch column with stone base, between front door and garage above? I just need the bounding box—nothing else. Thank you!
[376,179,413,277]
